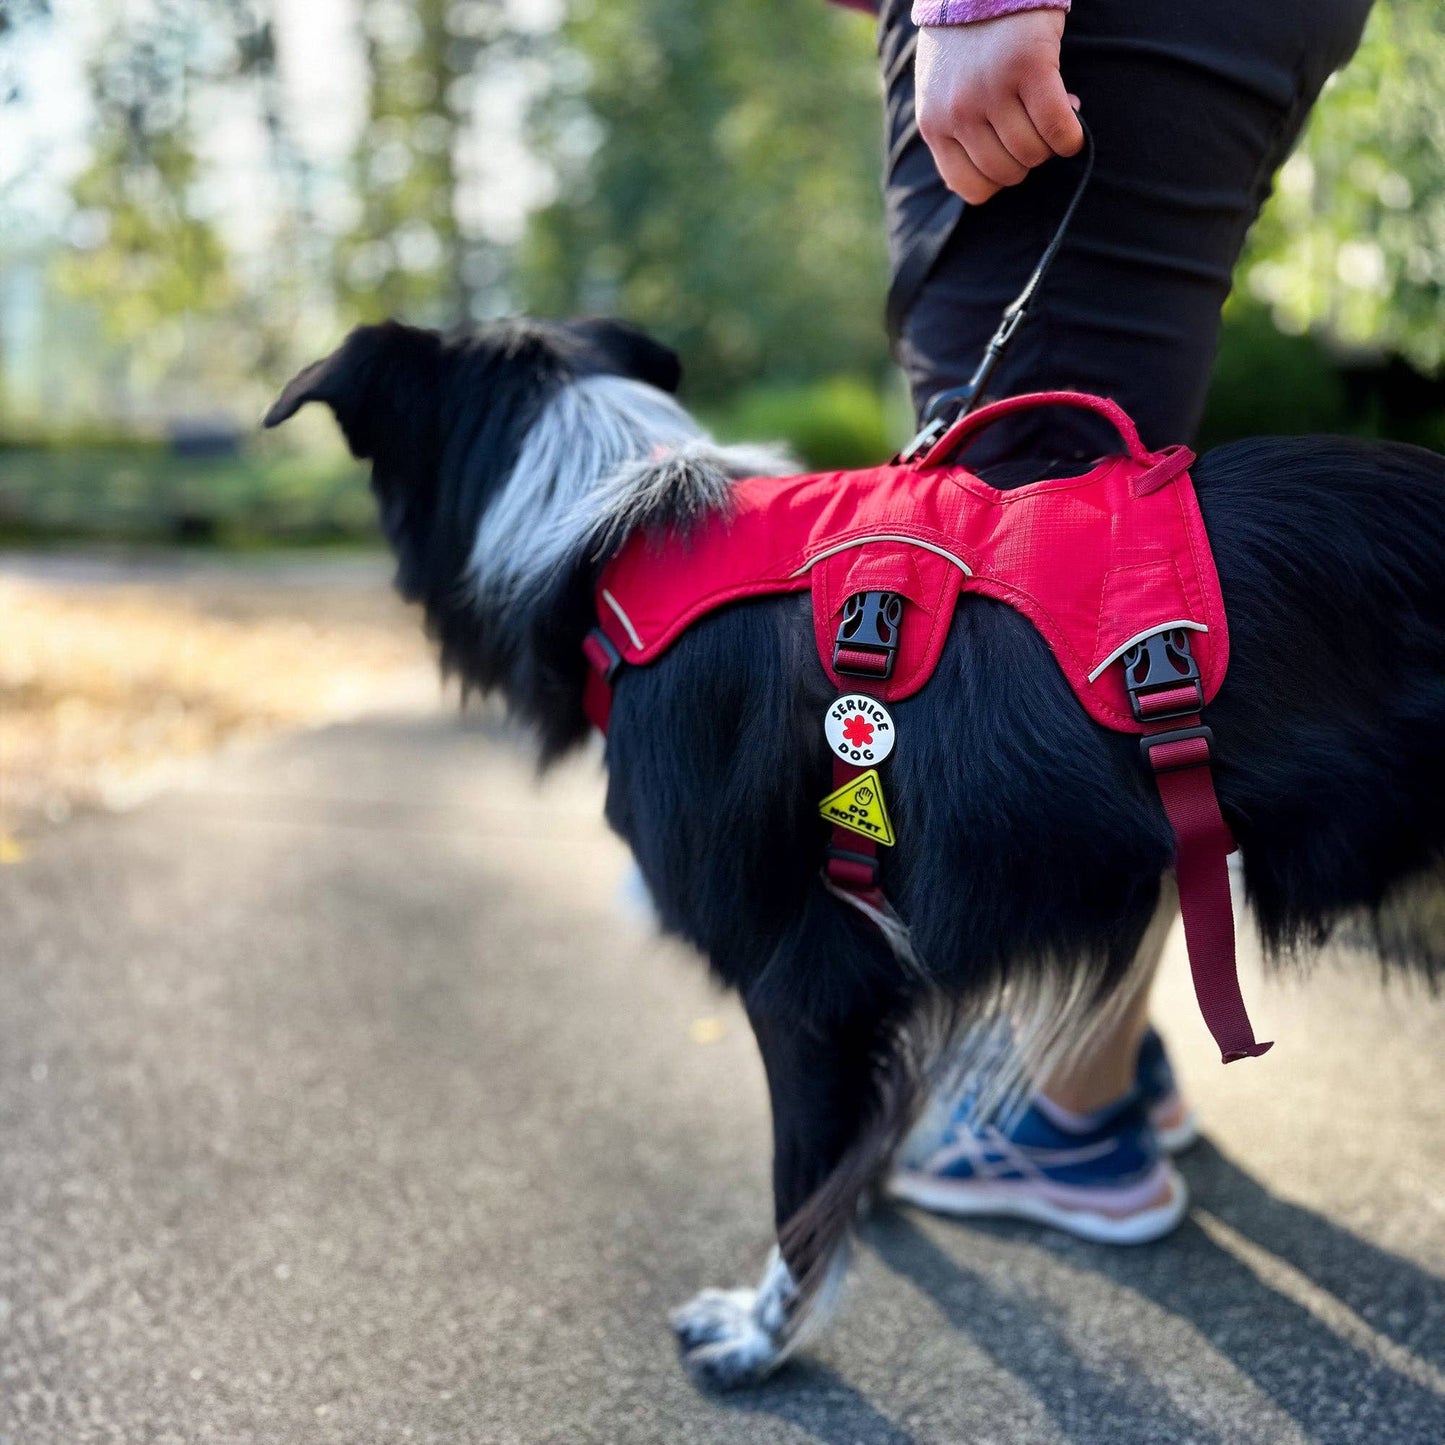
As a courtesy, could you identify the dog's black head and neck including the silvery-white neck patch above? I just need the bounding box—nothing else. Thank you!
[266,321,698,757]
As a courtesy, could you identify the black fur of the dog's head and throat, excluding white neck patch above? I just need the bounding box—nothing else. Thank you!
[264,319,682,760]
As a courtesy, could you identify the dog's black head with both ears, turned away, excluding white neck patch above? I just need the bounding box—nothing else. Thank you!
[264,321,682,608]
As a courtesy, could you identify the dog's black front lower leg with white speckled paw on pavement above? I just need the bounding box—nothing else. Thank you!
[672,1009,899,1389]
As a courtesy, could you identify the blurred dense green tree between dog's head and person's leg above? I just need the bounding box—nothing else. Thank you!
[516,0,887,397]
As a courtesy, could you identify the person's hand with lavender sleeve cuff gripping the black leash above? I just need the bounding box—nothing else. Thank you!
[915,10,1084,205]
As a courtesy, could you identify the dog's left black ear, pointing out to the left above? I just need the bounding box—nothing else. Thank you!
[262,321,441,461]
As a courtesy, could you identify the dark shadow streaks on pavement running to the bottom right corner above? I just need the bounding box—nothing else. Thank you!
[864,1142,1445,1445]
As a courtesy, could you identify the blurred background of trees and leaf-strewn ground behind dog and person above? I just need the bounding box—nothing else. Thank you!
[0,0,1445,832]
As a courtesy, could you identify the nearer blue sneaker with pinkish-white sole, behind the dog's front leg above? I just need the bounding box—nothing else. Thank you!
[887,1090,1189,1244]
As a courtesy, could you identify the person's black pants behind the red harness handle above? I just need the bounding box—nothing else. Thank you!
[879,0,1370,465]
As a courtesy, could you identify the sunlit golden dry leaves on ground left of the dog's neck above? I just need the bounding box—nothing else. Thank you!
[0,571,436,838]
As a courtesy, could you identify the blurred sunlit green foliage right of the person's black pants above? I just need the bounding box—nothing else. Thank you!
[1241,0,1445,371]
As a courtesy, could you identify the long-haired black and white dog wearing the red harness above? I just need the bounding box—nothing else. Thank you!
[266,322,1445,1384]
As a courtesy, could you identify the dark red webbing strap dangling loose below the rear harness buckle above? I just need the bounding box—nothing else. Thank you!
[1144,710,1274,1064]
